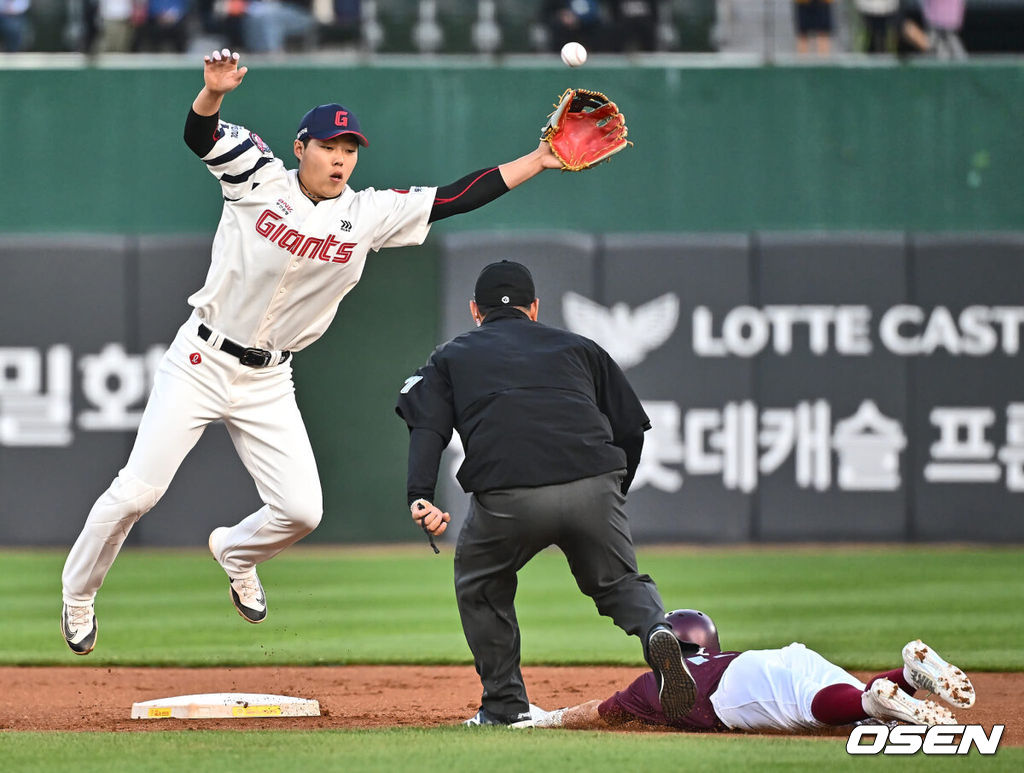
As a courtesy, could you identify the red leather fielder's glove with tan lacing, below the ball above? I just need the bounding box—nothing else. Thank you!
[541,89,633,172]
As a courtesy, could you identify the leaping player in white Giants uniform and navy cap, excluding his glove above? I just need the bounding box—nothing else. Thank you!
[60,49,561,655]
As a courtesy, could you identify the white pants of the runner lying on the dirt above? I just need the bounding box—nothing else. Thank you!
[711,643,866,731]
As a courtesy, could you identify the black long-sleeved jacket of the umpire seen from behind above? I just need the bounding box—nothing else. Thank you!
[395,308,650,503]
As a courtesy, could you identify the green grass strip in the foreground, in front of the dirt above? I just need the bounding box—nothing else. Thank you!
[0,728,1024,773]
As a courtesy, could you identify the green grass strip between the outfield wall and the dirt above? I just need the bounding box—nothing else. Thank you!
[8,546,1024,671]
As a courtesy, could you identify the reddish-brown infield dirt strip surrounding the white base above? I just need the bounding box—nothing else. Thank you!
[0,665,1024,745]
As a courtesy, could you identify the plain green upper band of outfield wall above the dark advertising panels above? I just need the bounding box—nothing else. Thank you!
[0,58,1024,233]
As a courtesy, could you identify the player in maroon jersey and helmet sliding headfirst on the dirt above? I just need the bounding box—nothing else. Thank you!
[513,609,975,733]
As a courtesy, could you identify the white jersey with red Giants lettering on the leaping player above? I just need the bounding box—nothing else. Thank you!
[188,121,436,351]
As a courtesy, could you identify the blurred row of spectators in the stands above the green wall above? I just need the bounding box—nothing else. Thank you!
[0,0,1024,58]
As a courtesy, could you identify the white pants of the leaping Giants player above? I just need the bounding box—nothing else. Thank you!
[61,314,324,604]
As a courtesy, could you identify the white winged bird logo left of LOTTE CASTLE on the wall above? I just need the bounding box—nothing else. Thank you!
[562,292,679,371]
